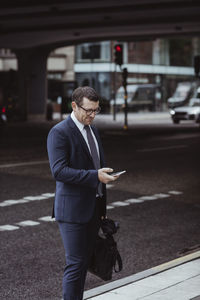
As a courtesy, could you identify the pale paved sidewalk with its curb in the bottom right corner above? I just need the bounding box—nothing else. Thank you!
[84,251,200,300]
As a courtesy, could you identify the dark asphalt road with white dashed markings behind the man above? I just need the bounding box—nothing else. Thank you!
[0,114,200,300]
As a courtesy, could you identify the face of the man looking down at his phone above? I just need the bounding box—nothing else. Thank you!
[72,97,99,125]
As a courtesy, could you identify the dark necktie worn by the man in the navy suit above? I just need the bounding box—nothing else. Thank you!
[84,125,102,196]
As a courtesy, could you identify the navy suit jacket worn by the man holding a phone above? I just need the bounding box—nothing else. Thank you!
[47,116,106,223]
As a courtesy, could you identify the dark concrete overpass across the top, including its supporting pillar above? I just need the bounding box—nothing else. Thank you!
[0,0,200,119]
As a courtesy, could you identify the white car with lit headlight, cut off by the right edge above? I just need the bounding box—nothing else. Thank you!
[170,88,200,124]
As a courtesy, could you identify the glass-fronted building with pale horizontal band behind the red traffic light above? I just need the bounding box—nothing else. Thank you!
[74,38,200,107]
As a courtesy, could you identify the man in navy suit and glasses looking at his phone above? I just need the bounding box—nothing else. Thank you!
[47,87,118,300]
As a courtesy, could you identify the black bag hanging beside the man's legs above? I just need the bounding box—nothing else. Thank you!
[88,219,122,281]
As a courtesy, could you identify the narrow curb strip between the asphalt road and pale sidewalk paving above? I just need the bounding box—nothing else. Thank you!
[83,251,200,300]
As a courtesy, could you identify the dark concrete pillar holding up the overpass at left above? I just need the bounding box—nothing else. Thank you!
[16,48,49,120]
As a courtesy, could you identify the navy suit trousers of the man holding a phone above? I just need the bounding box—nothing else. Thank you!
[58,198,101,300]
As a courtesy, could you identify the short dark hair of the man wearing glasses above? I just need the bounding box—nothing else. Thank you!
[72,86,99,105]
